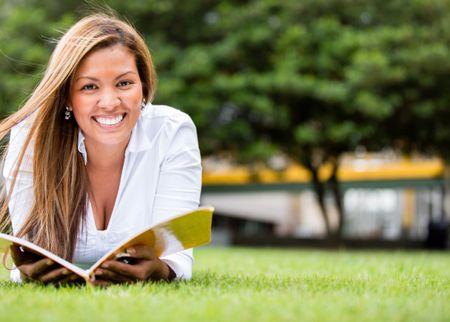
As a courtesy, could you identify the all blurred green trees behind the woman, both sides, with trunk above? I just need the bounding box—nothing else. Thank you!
[0,0,450,236]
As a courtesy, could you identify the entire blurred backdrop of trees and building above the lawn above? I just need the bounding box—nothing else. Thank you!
[0,0,450,249]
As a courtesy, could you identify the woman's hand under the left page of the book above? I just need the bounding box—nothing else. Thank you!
[10,245,78,284]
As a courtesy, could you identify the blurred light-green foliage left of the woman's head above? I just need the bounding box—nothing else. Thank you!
[0,0,74,117]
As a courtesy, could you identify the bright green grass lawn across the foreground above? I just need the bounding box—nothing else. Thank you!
[0,247,450,322]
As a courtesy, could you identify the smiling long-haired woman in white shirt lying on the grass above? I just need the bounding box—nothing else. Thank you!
[0,14,201,285]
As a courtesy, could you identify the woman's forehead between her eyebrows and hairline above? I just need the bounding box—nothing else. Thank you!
[75,45,137,77]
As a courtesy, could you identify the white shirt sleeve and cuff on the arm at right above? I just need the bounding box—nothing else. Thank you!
[153,116,202,280]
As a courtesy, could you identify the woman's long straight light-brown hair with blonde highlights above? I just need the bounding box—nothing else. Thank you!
[0,14,156,260]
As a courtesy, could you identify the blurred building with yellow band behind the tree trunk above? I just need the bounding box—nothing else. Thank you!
[202,154,446,242]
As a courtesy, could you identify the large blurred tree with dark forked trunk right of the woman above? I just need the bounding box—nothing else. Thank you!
[149,0,450,237]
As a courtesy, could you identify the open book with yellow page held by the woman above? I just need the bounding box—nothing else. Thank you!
[0,207,214,283]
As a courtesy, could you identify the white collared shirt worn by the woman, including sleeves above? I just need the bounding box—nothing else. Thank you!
[3,104,201,279]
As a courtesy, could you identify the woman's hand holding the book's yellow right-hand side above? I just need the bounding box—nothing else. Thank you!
[94,245,176,286]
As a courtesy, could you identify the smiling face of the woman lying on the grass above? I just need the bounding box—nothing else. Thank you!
[69,45,143,150]
